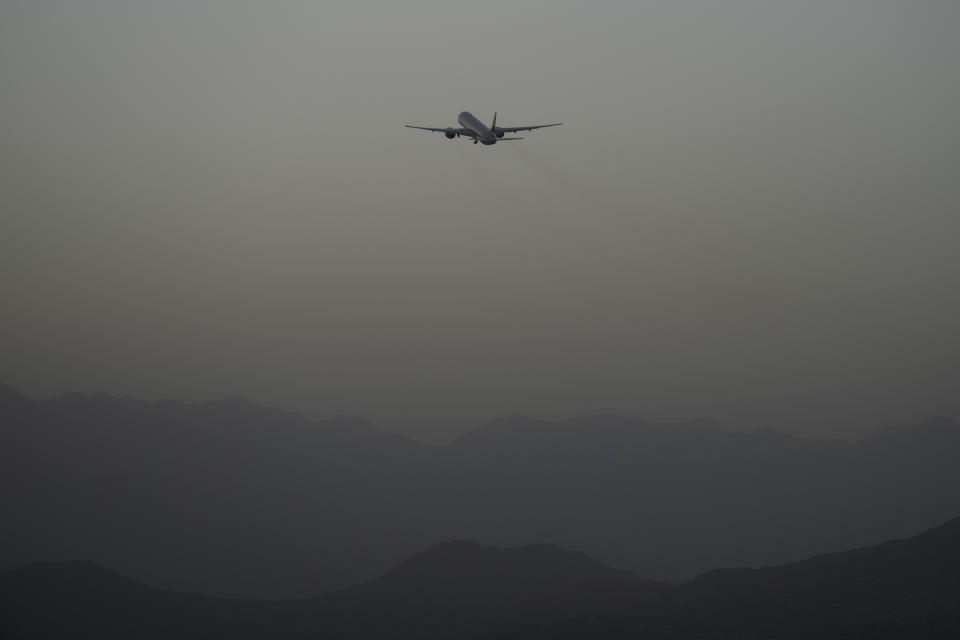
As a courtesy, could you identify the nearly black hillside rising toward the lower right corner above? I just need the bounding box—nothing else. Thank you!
[492,518,960,639]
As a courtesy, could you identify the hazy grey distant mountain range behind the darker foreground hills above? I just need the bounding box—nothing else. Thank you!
[0,388,960,598]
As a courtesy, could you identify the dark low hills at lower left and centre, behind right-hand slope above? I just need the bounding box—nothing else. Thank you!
[0,542,670,639]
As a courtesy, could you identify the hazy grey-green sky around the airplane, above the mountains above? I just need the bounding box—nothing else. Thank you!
[0,0,960,435]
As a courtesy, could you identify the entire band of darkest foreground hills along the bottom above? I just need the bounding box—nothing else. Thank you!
[0,518,960,640]
